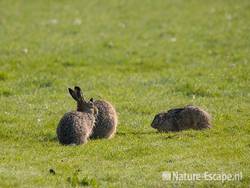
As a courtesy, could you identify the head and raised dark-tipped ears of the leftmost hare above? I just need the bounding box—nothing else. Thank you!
[68,86,98,115]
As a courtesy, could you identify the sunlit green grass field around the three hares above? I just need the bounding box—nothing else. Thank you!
[0,0,250,187]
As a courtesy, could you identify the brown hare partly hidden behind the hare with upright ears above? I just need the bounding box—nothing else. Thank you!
[90,100,118,139]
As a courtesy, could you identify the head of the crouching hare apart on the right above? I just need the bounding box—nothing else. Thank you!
[151,112,175,132]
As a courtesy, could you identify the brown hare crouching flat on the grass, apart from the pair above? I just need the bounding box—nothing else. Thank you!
[151,105,212,132]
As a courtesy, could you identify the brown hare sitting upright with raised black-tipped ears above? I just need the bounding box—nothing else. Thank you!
[56,86,98,145]
